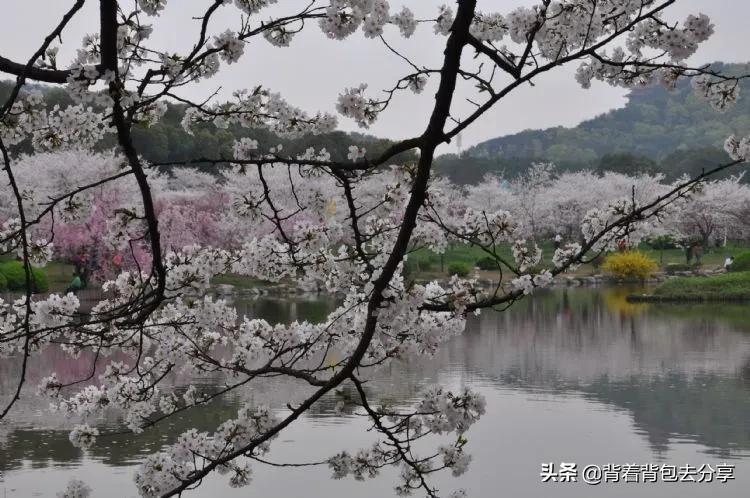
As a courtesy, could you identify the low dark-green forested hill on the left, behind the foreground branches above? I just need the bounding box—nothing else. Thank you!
[0,81,418,169]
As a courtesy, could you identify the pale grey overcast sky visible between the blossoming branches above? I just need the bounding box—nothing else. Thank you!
[0,0,750,152]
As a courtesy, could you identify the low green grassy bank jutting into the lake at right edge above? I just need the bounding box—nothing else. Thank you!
[631,272,750,302]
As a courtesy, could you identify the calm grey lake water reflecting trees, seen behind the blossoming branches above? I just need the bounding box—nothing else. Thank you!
[0,288,750,498]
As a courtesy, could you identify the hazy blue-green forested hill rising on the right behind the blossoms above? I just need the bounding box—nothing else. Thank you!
[440,63,750,183]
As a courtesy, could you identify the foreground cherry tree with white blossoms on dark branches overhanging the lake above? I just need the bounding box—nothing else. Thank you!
[0,0,750,496]
